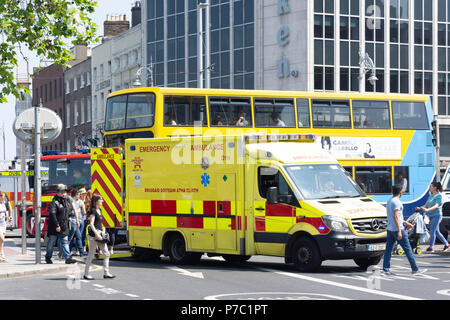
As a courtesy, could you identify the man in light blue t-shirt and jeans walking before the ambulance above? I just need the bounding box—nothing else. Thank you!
[383,184,426,275]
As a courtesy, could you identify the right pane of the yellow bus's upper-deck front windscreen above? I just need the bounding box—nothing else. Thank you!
[127,93,155,129]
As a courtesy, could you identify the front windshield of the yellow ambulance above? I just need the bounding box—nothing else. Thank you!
[285,164,365,200]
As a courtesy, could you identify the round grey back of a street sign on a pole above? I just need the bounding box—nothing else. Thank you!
[13,107,62,143]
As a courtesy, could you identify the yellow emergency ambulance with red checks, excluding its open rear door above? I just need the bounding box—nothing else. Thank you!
[120,134,387,271]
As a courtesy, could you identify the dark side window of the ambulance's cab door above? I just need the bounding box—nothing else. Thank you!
[258,167,297,205]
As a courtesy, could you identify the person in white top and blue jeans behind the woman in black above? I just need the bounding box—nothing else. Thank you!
[69,189,87,256]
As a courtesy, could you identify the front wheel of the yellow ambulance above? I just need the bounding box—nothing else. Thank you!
[292,237,322,272]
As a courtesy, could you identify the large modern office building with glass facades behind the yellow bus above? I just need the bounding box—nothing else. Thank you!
[143,0,450,160]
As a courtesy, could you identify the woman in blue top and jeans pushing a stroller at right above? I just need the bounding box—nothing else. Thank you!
[420,182,449,253]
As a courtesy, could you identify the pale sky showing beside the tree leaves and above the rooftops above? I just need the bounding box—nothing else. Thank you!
[0,0,135,160]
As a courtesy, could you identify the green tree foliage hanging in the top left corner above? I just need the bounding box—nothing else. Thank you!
[0,0,98,102]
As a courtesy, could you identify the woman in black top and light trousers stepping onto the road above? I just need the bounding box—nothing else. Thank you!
[84,194,116,280]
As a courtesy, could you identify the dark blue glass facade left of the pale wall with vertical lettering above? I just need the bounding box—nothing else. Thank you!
[144,0,255,89]
